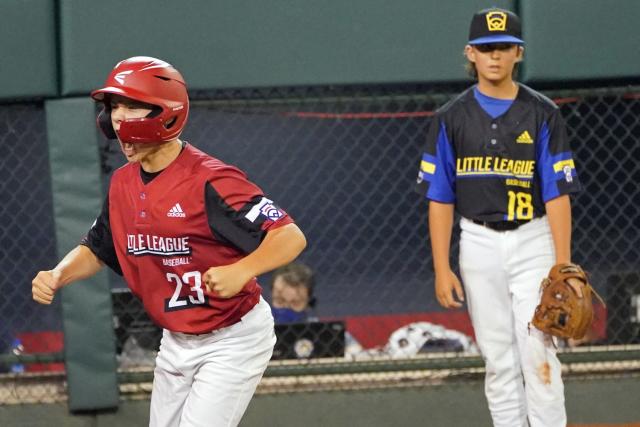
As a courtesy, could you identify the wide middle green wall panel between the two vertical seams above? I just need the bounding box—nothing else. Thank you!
[59,0,514,95]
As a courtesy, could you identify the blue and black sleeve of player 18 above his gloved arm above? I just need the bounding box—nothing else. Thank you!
[536,110,582,203]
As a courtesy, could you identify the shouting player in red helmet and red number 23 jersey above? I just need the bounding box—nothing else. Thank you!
[32,57,306,426]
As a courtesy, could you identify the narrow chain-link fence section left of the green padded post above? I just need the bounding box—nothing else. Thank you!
[0,104,64,402]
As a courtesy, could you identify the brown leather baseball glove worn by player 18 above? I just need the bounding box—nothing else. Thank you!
[532,264,604,339]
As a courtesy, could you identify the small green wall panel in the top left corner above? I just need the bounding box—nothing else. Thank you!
[0,0,58,100]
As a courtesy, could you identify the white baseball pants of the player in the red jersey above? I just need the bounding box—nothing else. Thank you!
[149,298,276,427]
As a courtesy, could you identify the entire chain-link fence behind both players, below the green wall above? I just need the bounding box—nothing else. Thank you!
[0,86,640,404]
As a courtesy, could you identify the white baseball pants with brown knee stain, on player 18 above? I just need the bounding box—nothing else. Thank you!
[460,217,567,427]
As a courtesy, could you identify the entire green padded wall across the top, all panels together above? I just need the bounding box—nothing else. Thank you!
[5,0,640,101]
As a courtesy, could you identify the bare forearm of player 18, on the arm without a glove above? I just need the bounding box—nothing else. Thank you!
[429,201,453,274]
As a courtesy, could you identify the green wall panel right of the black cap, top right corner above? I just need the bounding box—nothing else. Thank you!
[519,0,640,81]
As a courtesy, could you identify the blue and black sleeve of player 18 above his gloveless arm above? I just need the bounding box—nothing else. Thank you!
[416,117,456,203]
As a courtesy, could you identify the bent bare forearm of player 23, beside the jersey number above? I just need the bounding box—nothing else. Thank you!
[238,224,307,276]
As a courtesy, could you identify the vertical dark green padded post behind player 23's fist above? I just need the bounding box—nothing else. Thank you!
[45,98,118,411]
